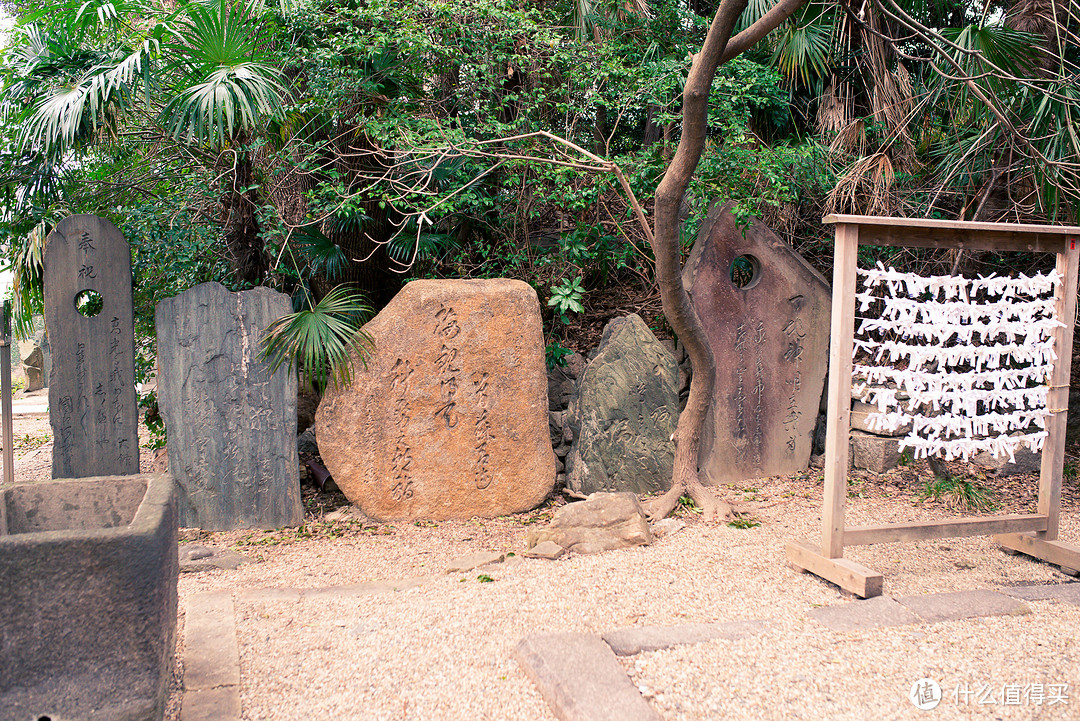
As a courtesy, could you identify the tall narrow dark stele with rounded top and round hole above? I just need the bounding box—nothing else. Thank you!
[44,215,138,478]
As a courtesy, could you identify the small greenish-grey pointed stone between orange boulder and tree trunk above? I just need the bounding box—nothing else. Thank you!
[566,314,678,494]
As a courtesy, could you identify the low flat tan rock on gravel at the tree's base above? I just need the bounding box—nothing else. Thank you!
[528,493,652,554]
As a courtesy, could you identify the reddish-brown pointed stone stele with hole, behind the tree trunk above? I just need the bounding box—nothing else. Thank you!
[683,205,832,484]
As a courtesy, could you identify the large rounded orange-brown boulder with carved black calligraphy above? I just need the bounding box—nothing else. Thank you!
[315,278,555,520]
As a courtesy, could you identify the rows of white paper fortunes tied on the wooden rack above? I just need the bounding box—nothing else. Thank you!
[853,263,1064,461]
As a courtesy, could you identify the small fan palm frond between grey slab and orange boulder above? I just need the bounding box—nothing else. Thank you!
[262,286,375,389]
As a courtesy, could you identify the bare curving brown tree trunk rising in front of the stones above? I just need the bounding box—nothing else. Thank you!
[649,0,802,520]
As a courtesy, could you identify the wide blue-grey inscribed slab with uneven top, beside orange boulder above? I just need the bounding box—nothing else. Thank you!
[156,283,303,530]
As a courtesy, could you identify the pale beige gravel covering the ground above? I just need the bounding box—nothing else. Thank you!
[10,410,1080,721]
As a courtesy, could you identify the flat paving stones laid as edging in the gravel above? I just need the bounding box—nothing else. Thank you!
[180,577,1080,721]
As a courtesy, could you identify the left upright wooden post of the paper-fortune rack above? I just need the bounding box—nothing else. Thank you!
[821,223,859,558]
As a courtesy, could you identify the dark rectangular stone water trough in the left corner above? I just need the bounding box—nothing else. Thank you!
[0,474,177,721]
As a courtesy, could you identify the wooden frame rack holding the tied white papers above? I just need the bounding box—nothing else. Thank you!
[787,215,1080,598]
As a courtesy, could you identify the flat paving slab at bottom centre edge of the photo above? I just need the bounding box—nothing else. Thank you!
[514,632,660,721]
